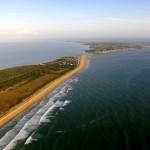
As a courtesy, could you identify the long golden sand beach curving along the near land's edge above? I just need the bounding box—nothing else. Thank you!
[0,53,88,127]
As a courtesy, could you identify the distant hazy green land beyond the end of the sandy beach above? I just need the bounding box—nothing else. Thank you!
[86,42,147,54]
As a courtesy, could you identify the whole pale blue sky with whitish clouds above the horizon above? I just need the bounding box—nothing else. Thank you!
[0,0,150,41]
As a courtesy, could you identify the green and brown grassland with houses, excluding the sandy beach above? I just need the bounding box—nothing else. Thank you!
[0,57,78,116]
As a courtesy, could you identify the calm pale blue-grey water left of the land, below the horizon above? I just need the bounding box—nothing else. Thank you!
[0,40,88,68]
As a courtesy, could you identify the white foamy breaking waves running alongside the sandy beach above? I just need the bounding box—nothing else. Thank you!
[0,77,78,150]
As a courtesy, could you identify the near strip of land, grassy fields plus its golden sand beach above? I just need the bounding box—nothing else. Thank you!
[0,54,87,126]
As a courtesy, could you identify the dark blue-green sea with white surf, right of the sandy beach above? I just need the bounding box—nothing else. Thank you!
[0,41,150,150]
